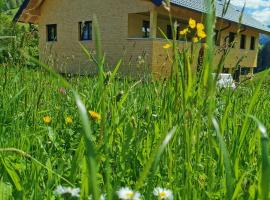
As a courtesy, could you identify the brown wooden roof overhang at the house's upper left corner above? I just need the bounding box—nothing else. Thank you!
[13,0,44,24]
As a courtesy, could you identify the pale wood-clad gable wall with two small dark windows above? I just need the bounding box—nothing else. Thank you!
[38,0,153,74]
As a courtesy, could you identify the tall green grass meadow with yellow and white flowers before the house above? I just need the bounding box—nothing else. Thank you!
[0,0,270,200]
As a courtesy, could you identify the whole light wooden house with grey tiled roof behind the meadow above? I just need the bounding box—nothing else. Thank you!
[14,0,270,76]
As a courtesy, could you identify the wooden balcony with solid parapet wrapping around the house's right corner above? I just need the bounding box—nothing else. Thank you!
[127,10,257,77]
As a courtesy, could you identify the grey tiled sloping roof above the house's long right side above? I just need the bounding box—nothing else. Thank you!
[171,0,270,33]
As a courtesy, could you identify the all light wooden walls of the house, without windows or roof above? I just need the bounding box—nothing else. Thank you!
[38,0,258,75]
